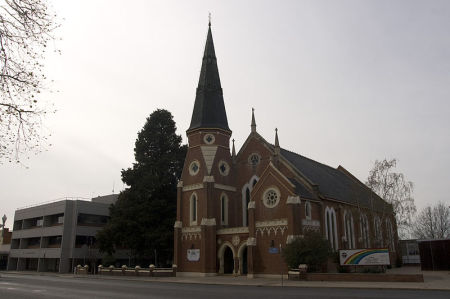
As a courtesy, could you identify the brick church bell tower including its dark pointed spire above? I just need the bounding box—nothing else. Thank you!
[174,22,236,275]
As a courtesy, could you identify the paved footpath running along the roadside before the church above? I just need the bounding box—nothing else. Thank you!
[0,267,450,291]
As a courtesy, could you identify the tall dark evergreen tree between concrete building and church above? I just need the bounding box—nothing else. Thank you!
[97,109,187,263]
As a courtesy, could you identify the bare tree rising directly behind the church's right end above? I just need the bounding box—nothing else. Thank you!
[366,159,416,238]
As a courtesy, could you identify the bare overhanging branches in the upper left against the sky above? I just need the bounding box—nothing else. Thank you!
[0,0,58,162]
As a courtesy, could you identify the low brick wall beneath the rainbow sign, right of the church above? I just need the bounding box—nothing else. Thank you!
[289,271,423,282]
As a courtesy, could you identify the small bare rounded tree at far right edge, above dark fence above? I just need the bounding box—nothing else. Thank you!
[413,202,450,239]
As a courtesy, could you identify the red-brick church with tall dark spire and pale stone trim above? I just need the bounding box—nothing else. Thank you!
[174,24,398,277]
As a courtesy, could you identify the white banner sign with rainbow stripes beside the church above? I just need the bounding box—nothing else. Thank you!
[339,248,390,266]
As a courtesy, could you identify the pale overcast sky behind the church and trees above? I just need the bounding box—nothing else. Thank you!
[0,0,450,226]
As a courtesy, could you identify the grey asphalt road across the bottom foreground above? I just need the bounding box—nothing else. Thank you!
[0,274,450,299]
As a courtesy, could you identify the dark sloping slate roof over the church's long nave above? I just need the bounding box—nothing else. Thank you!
[280,149,384,210]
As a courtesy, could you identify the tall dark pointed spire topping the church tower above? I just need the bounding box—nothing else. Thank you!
[187,20,231,132]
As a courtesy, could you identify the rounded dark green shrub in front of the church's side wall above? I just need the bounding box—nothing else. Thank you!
[283,231,331,271]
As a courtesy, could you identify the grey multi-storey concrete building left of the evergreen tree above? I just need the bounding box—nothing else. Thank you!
[8,194,117,273]
